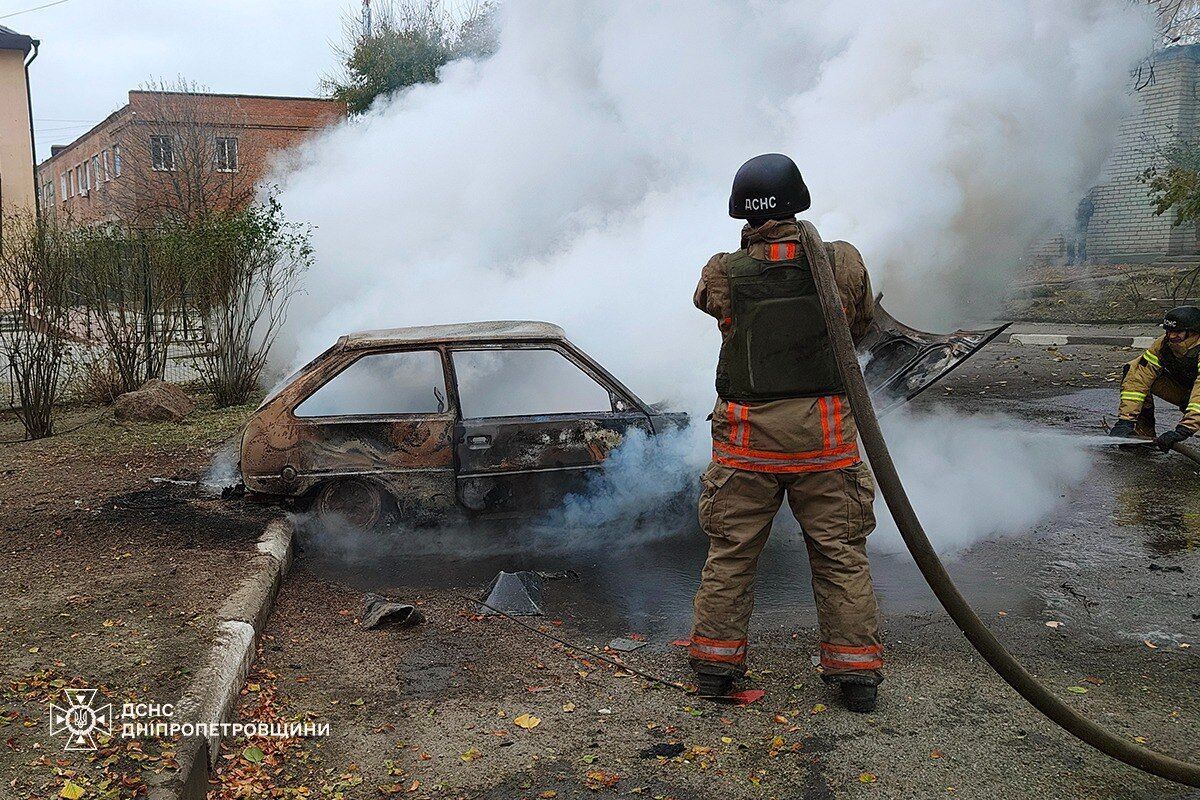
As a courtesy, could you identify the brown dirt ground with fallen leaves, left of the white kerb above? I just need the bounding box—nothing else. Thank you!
[0,398,272,798]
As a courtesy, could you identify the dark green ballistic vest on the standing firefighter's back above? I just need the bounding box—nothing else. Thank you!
[716,247,844,401]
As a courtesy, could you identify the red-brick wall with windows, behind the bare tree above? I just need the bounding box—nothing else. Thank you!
[37,91,344,224]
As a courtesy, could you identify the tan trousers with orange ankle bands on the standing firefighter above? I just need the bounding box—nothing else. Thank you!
[689,463,883,681]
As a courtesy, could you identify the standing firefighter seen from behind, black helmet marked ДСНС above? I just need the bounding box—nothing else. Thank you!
[689,154,883,712]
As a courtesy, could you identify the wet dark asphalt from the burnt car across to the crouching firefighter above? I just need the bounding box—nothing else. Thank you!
[302,345,1200,652]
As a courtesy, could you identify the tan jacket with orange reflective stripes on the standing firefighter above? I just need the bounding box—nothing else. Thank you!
[694,221,875,473]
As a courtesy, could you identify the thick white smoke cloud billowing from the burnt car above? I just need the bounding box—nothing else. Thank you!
[276,0,1153,549]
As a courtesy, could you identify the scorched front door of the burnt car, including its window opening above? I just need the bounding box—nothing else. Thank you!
[450,343,652,516]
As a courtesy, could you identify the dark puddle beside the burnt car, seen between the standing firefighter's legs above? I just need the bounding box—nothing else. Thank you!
[297,519,1016,638]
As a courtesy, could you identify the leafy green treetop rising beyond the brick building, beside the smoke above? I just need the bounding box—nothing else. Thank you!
[324,0,496,114]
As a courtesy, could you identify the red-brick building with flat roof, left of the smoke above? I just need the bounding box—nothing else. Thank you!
[36,90,346,224]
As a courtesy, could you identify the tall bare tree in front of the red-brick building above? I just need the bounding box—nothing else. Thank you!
[112,79,254,227]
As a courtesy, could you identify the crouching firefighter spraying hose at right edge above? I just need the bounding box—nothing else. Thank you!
[1109,306,1200,452]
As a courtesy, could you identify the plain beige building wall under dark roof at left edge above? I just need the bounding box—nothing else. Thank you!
[0,50,35,215]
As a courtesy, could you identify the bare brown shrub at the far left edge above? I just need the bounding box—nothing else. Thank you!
[0,215,73,439]
